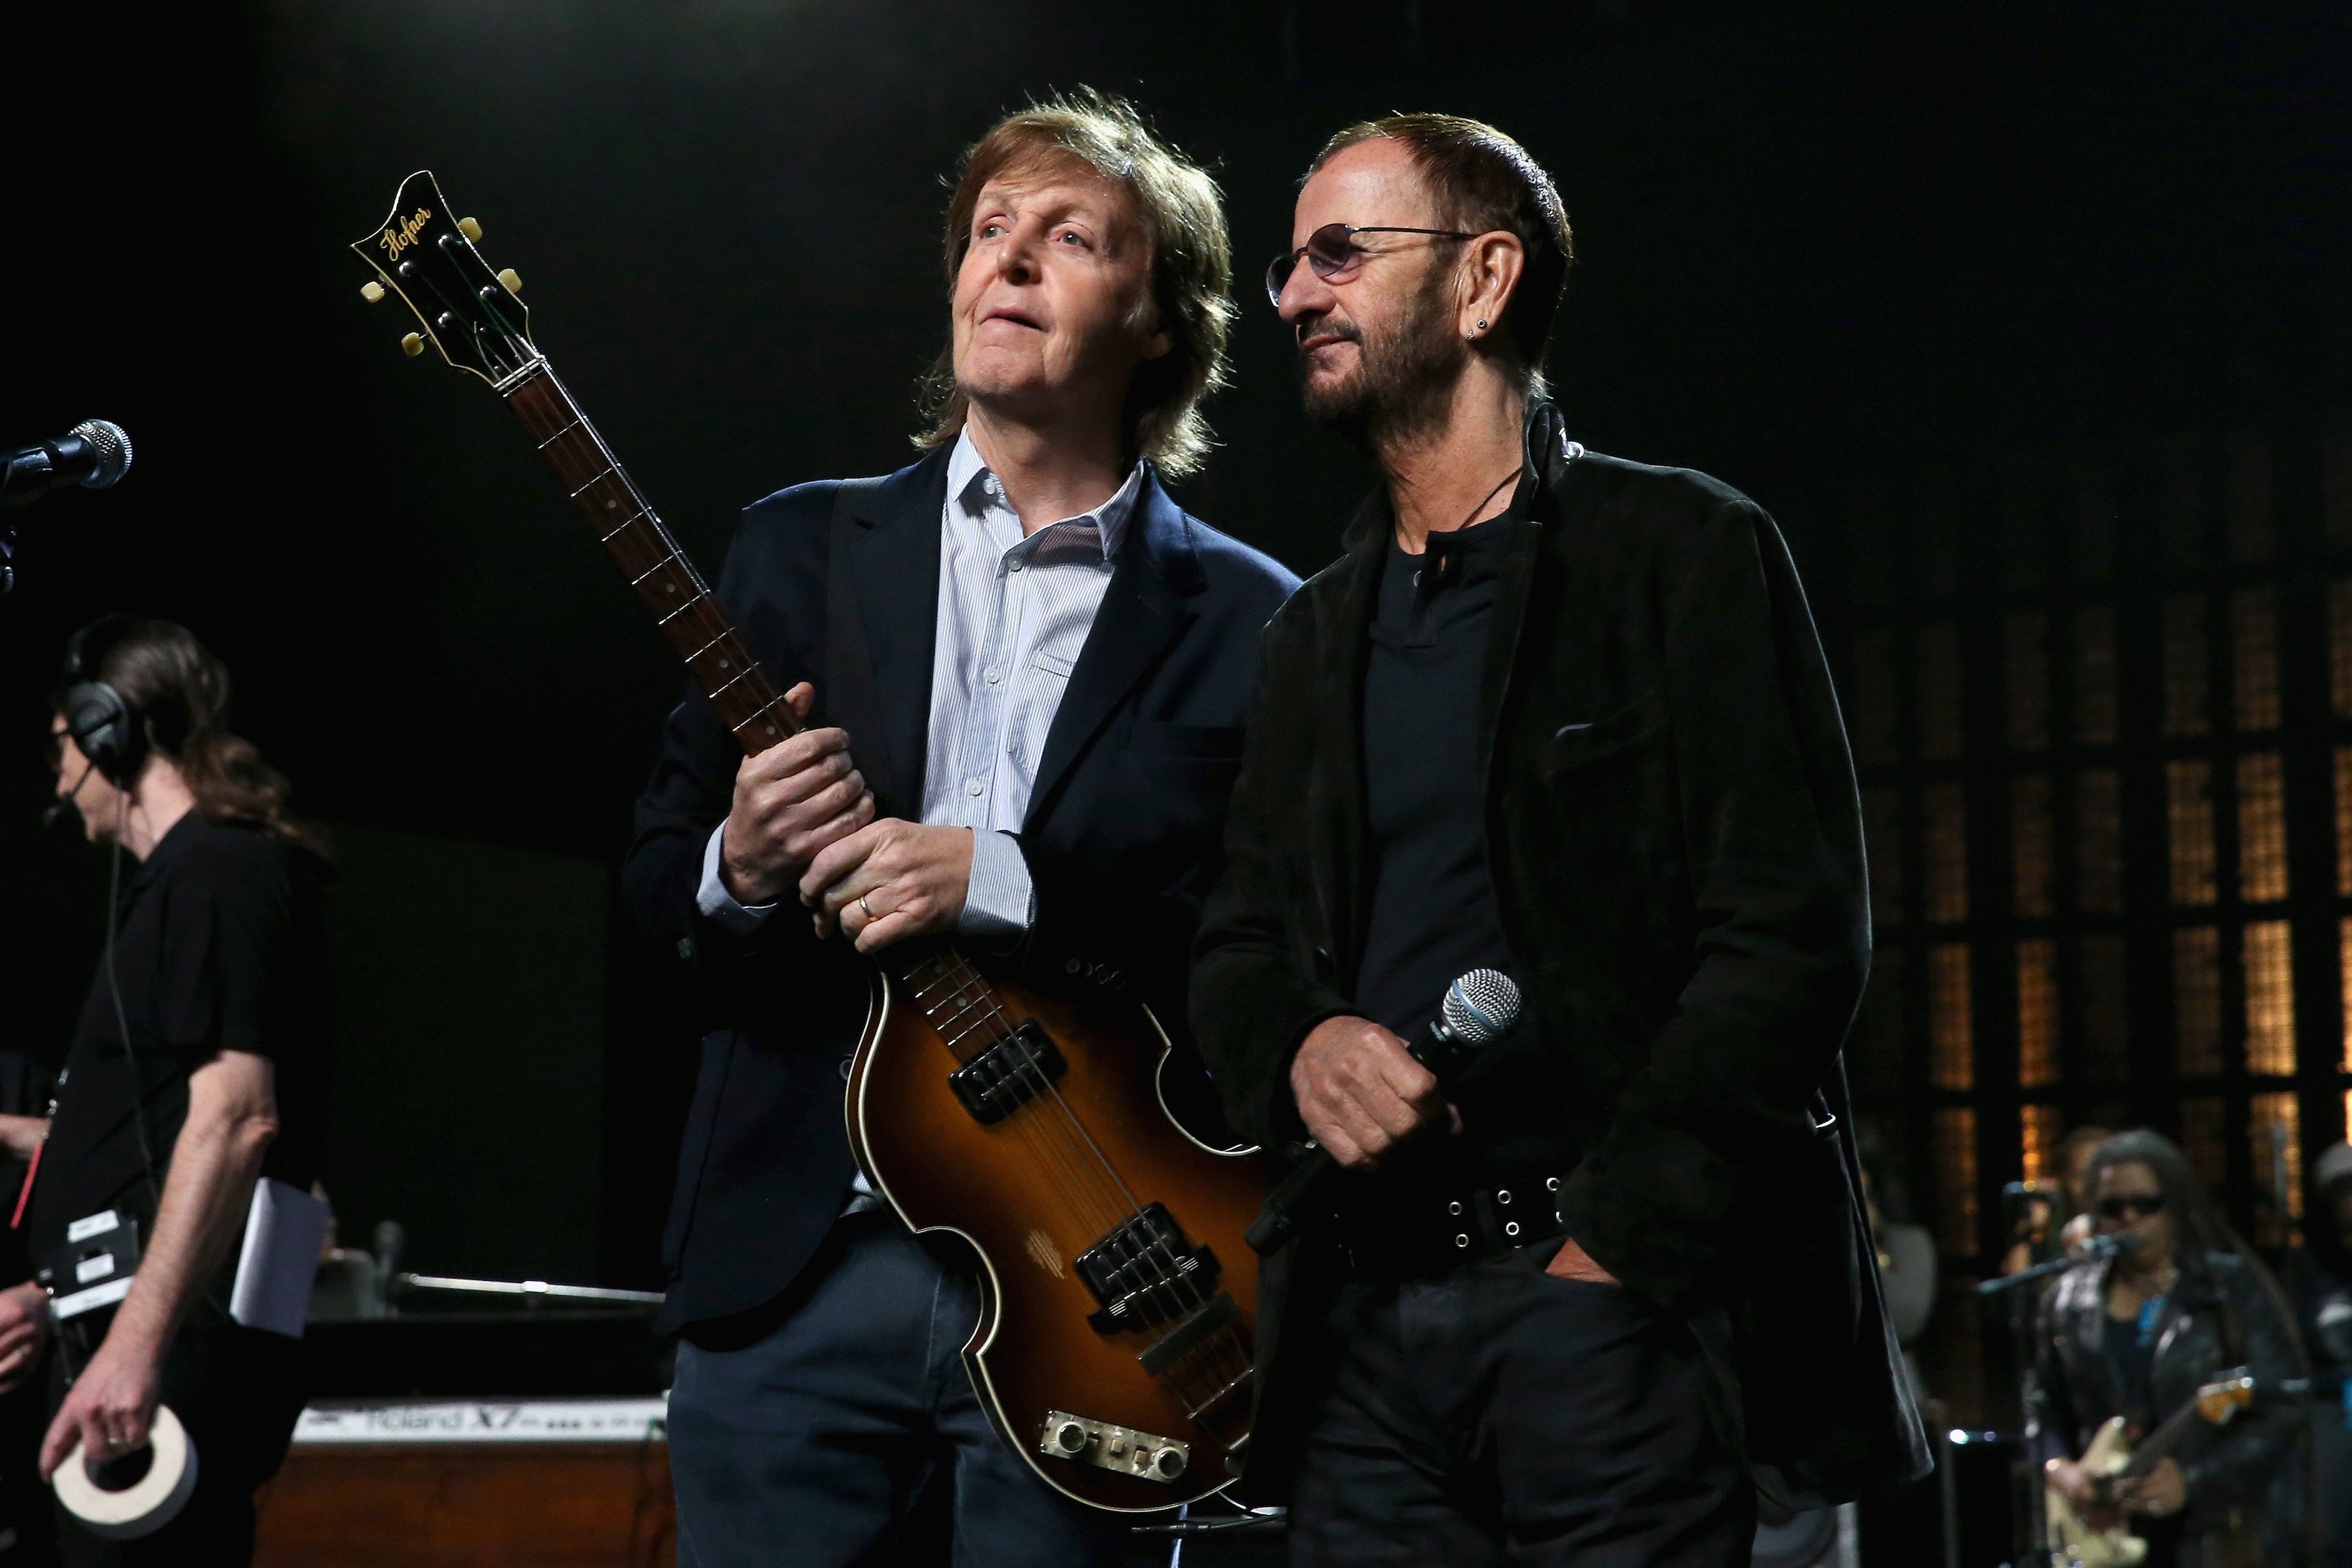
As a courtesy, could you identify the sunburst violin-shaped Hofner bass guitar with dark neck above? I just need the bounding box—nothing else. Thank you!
[353,172,1260,1511]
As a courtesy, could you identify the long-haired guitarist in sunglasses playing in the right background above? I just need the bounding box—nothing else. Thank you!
[2027,1129,2303,1568]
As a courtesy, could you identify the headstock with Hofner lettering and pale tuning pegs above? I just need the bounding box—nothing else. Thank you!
[351,169,539,386]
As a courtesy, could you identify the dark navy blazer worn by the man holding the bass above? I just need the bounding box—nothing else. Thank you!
[623,451,1296,1329]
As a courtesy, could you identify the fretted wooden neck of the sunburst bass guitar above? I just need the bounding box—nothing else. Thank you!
[506,362,1011,1034]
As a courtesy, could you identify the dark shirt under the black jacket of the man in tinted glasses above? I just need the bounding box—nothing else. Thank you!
[1355,477,1576,1185]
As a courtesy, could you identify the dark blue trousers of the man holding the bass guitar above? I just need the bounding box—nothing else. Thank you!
[670,1213,1169,1568]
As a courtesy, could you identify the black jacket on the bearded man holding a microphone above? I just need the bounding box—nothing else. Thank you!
[1192,402,1926,1502]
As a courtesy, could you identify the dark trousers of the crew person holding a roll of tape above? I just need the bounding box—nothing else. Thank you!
[49,1314,308,1568]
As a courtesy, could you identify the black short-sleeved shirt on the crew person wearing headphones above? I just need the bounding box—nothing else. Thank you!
[26,811,334,1267]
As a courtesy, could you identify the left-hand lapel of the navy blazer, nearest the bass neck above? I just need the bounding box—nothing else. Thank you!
[825,449,948,821]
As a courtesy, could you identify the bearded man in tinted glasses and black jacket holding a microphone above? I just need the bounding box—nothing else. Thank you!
[1192,115,1926,1568]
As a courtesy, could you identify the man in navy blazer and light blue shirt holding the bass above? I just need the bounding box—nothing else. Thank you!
[625,94,1296,1568]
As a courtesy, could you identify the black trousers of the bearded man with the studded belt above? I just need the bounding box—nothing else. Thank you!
[1291,1244,1754,1568]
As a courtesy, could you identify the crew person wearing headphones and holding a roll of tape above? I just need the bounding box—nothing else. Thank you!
[0,616,331,1564]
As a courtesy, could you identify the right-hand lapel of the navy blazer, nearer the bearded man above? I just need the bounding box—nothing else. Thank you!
[1023,472,1202,827]
